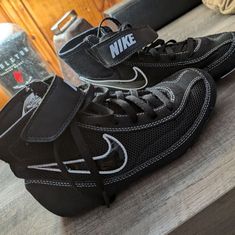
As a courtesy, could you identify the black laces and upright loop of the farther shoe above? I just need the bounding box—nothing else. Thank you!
[97,17,195,60]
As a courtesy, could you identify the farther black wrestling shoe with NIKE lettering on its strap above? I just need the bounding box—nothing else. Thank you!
[59,18,235,90]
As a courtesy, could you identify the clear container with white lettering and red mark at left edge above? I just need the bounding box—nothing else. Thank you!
[0,23,52,110]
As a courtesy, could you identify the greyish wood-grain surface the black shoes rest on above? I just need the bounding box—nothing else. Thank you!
[0,6,235,235]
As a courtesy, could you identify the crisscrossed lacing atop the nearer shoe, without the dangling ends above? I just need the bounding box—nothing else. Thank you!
[83,85,173,123]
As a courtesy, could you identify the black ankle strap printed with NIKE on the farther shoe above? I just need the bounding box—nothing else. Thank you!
[88,26,157,68]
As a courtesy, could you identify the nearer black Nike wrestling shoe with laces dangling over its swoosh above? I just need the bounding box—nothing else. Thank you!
[0,69,216,216]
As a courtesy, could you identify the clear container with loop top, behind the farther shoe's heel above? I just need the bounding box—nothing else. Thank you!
[51,10,92,86]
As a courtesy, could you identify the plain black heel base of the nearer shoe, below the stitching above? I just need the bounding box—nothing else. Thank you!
[25,182,103,217]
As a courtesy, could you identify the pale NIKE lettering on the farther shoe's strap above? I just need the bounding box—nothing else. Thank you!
[109,33,136,59]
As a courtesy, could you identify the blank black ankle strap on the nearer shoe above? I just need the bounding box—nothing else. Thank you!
[21,77,85,142]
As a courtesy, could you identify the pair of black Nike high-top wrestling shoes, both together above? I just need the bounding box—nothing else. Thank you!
[0,20,235,216]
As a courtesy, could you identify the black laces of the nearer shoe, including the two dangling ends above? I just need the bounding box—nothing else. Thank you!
[53,85,172,207]
